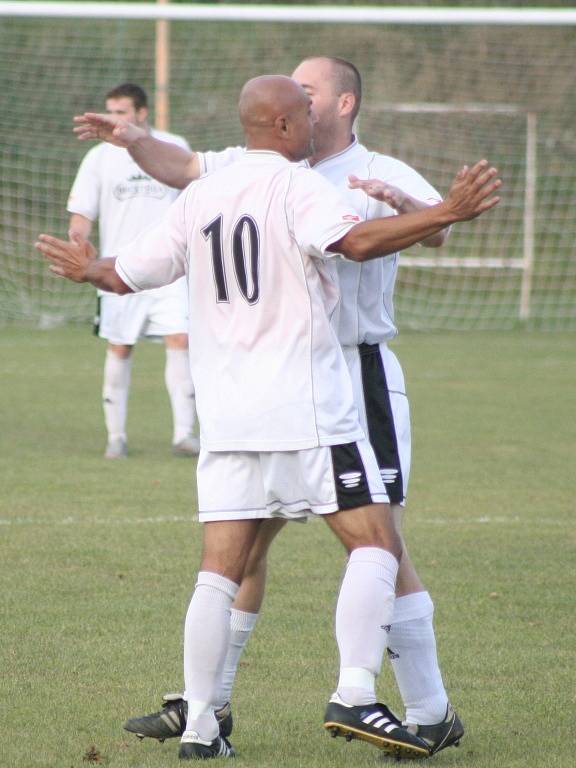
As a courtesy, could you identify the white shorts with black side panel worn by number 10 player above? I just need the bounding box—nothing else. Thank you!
[198,440,388,523]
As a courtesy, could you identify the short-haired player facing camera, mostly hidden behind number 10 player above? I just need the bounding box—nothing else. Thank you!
[75,57,488,752]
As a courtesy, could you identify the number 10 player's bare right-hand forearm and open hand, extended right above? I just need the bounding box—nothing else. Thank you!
[329,160,502,261]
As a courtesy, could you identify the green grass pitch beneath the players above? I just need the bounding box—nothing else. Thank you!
[0,328,576,768]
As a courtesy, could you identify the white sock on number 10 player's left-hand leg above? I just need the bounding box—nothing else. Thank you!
[184,571,238,741]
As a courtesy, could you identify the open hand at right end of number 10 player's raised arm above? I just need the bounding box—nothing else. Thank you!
[444,160,502,221]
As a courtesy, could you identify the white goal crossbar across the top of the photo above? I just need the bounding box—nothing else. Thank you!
[0,2,576,26]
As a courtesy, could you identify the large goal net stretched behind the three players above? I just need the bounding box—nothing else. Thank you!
[0,2,576,330]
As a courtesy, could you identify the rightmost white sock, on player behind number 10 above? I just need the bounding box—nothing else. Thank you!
[387,592,448,725]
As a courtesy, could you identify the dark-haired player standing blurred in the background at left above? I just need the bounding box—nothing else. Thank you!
[68,83,199,459]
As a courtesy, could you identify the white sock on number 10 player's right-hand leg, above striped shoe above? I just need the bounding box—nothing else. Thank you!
[336,547,398,706]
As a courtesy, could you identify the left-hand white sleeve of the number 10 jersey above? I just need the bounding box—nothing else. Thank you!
[116,190,189,291]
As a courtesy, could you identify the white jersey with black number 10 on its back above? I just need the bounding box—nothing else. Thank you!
[116,151,363,450]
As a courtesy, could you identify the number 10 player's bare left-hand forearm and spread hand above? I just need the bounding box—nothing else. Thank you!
[34,235,132,294]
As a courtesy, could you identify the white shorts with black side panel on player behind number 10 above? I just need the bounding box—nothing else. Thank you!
[343,344,411,505]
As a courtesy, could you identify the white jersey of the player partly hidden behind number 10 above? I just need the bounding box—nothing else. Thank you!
[198,138,442,346]
